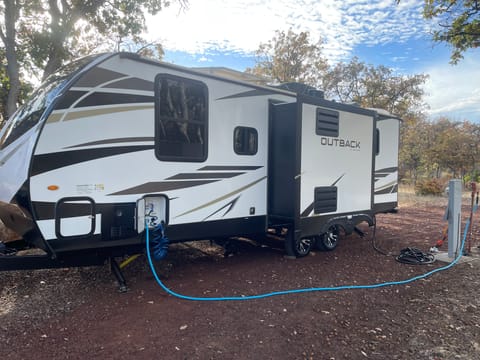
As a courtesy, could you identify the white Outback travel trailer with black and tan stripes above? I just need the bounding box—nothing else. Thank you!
[0,53,400,270]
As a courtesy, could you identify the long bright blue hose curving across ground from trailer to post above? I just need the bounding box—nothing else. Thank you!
[146,219,470,301]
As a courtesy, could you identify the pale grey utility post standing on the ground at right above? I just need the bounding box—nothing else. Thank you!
[448,179,462,259]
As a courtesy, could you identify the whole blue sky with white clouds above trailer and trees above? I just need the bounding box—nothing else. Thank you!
[147,0,480,123]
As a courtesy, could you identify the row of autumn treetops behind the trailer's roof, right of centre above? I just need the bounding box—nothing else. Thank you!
[247,29,427,121]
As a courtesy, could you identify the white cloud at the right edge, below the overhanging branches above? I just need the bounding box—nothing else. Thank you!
[424,50,480,122]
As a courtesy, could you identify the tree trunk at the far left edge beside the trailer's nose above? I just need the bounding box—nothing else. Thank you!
[0,0,20,117]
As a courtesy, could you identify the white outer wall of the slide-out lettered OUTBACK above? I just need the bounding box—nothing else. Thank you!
[299,101,375,217]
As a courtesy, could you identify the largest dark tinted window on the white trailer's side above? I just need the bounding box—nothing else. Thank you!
[155,74,208,161]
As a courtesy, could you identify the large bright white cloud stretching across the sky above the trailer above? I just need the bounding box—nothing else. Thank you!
[148,0,427,62]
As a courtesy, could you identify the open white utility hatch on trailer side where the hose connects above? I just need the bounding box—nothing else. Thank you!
[136,195,168,234]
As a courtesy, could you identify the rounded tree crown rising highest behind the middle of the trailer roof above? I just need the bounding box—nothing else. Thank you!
[247,29,327,85]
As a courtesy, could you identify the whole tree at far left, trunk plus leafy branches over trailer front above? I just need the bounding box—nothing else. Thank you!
[0,0,186,121]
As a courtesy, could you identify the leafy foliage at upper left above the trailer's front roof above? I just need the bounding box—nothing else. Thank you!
[19,0,173,78]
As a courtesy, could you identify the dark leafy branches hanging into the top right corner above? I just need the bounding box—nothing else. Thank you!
[423,0,480,64]
